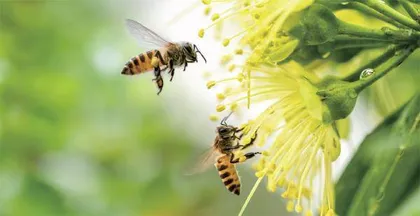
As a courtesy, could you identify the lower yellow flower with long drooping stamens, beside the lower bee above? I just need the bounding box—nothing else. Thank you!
[212,61,340,215]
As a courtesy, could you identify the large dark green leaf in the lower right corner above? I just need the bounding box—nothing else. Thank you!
[336,95,420,215]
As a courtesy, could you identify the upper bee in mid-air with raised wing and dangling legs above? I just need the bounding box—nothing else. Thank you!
[121,19,207,95]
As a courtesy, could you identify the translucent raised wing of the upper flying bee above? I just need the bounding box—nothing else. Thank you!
[125,19,170,47]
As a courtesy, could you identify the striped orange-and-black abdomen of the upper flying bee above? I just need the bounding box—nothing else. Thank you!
[121,50,165,75]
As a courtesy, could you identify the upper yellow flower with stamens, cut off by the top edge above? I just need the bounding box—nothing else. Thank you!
[199,0,314,64]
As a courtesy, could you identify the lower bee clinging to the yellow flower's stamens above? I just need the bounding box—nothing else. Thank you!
[189,113,261,195]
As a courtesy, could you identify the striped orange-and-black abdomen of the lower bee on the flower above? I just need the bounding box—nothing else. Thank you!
[214,155,241,195]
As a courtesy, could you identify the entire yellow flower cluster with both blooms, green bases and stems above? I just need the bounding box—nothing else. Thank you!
[199,0,420,216]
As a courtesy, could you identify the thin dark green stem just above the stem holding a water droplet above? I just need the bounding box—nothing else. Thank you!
[343,45,404,82]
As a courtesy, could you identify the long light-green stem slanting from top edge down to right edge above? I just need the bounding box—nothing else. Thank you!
[357,0,420,30]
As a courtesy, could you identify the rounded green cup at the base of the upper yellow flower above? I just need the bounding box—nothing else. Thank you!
[301,4,339,45]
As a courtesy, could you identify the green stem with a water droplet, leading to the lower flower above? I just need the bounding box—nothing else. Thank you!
[352,45,417,93]
